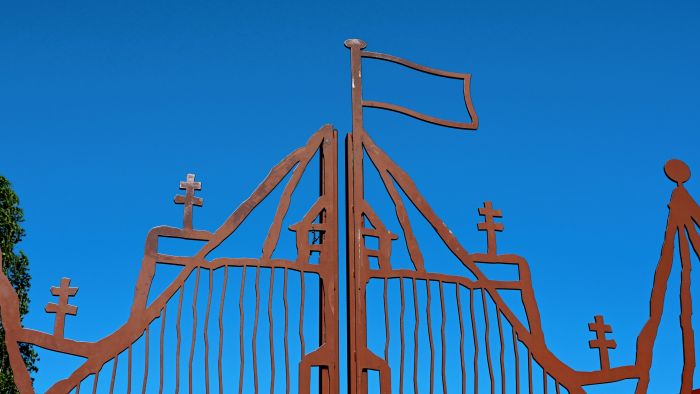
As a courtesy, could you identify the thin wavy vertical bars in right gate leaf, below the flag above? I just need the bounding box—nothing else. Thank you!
[367,277,568,394]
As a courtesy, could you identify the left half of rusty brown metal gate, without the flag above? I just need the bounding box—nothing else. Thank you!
[0,126,339,393]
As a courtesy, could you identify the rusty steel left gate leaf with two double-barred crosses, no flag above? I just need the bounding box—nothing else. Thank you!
[0,126,340,393]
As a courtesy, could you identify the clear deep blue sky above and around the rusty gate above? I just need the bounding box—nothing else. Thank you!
[0,1,700,393]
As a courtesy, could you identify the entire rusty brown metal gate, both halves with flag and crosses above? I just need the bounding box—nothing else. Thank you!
[0,40,700,394]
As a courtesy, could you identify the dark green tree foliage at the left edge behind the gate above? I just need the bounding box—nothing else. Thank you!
[0,175,38,393]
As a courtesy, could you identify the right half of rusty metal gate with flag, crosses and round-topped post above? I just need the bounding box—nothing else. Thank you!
[345,39,700,393]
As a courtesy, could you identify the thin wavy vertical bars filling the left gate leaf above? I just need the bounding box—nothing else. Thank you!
[73,266,321,394]
